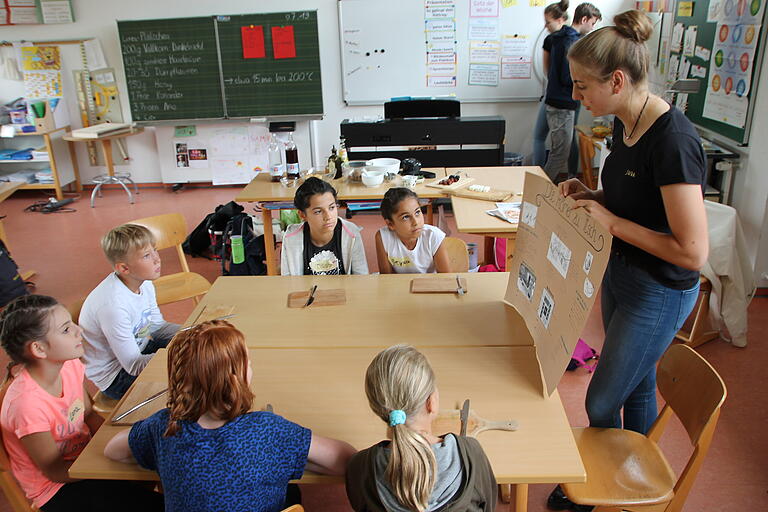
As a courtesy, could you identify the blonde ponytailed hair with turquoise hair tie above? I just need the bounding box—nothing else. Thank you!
[365,345,437,511]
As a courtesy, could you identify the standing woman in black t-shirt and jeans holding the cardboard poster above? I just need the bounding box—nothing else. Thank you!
[544,11,709,512]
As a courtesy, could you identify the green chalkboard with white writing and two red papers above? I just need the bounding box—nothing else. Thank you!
[117,11,323,122]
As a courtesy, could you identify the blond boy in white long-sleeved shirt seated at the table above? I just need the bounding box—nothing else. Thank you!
[79,224,179,399]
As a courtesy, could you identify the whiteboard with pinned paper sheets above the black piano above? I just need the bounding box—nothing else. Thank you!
[338,0,545,105]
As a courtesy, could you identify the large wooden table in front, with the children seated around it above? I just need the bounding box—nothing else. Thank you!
[70,273,586,511]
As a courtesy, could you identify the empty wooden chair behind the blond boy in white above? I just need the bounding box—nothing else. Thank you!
[130,213,211,304]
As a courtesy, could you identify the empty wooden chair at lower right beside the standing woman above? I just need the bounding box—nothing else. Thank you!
[562,344,726,512]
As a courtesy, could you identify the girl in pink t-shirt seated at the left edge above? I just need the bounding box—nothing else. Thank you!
[0,295,163,512]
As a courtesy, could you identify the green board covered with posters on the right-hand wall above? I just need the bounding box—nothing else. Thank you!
[669,0,766,145]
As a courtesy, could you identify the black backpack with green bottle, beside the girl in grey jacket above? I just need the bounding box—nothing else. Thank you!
[219,213,274,276]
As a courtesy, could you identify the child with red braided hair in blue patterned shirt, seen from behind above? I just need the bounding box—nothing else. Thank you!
[104,321,355,512]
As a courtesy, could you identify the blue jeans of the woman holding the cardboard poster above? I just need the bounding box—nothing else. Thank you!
[586,253,699,434]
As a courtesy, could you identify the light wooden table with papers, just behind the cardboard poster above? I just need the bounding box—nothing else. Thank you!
[445,166,547,272]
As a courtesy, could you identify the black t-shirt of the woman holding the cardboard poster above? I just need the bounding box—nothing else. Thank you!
[601,107,706,290]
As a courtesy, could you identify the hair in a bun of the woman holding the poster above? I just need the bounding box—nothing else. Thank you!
[568,10,653,84]
